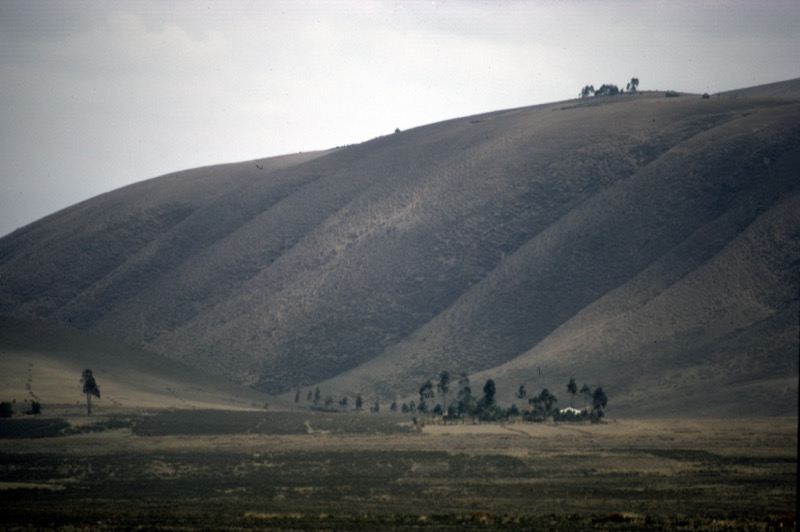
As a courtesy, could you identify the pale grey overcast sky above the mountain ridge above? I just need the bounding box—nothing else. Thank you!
[0,0,800,235]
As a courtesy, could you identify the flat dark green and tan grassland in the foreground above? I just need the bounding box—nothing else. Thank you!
[0,408,797,530]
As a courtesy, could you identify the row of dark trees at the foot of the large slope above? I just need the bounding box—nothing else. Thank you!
[294,371,608,422]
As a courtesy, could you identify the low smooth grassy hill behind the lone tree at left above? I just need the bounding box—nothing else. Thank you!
[0,317,274,415]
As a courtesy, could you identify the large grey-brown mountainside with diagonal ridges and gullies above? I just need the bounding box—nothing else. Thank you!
[0,80,800,415]
